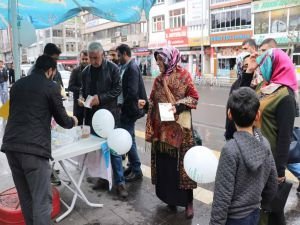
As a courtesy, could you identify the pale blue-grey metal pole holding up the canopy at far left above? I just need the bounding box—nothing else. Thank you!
[10,0,21,80]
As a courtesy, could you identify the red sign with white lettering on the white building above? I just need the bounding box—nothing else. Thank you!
[166,26,188,46]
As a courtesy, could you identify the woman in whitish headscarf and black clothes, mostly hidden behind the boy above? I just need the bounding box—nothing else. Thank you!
[224,52,253,140]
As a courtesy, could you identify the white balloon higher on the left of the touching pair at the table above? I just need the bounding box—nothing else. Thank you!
[92,109,115,138]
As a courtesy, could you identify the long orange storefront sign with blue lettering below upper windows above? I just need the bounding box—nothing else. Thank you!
[210,30,253,45]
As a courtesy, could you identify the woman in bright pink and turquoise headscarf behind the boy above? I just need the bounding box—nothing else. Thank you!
[247,48,298,225]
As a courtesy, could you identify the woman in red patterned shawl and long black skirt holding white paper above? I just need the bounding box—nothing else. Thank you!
[146,47,198,219]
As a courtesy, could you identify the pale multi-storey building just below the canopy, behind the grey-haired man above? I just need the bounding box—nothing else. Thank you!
[81,13,151,75]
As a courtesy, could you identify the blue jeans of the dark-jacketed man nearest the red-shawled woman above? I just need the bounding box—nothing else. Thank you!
[121,119,142,174]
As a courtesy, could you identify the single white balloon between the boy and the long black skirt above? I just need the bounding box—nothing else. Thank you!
[183,146,218,184]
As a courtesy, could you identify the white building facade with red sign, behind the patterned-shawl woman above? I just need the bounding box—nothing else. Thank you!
[148,0,211,77]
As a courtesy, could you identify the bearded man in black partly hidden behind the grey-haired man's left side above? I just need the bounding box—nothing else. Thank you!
[68,50,89,125]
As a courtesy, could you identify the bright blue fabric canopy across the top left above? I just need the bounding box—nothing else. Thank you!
[0,0,155,29]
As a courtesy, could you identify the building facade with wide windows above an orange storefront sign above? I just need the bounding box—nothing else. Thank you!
[210,0,253,78]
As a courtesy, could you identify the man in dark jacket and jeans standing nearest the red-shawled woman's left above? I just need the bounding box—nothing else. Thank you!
[117,44,147,182]
